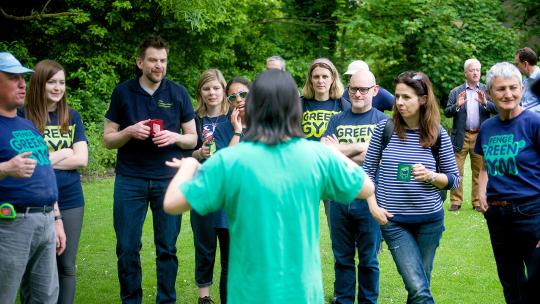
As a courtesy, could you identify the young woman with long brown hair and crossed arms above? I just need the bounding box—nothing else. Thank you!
[24,60,88,303]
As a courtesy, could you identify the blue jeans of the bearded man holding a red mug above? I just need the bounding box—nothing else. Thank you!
[114,175,182,303]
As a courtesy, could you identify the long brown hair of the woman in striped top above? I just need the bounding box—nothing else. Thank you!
[392,71,441,148]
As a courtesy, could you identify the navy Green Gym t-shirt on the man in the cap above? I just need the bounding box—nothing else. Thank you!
[0,115,58,207]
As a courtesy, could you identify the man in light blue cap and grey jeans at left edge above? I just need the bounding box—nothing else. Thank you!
[0,52,66,303]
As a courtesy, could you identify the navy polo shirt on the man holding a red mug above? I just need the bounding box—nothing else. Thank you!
[105,78,195,179]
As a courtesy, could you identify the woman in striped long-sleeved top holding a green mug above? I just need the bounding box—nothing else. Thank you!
[364,72,460,303]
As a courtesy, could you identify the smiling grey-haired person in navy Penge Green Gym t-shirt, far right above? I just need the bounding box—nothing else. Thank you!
[474,62,540,304]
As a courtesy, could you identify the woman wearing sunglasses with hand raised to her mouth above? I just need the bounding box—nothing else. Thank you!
[216,77,251,149]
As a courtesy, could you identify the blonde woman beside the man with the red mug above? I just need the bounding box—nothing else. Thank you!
[190,69,230,304]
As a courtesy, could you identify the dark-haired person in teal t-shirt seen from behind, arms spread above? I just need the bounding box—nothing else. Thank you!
[164,70,374,304]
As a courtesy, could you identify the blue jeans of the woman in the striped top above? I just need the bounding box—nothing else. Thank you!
[381,219,444,303]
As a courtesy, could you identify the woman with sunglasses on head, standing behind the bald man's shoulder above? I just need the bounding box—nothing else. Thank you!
[301,58,351,140]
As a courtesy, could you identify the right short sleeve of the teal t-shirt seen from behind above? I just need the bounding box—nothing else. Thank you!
[322,150,366,202]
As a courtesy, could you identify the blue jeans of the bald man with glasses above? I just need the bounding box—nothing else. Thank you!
[330,200,381,304]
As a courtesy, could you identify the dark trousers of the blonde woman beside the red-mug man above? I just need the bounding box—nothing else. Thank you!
[190,210,229,303]
